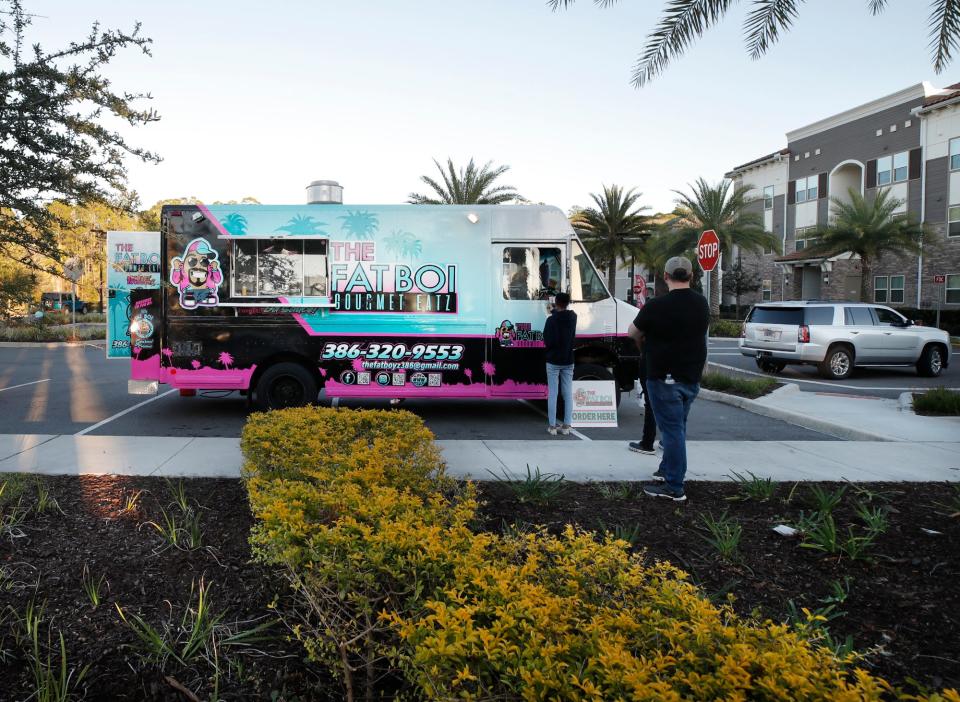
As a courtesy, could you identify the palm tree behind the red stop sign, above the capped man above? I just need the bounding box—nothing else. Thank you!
[670,178,777,317]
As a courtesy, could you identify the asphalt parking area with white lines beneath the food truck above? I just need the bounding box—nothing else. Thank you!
[0,345,833,441]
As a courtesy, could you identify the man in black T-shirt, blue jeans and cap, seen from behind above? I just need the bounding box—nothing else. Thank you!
[629,256,710,502]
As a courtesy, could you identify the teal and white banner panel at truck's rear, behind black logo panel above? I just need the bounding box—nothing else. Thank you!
[106,232,160,358]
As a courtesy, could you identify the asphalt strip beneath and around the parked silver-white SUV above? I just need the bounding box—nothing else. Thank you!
[710,339,960,397]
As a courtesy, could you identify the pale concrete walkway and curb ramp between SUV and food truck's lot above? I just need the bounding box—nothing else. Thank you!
[700,383,960,442]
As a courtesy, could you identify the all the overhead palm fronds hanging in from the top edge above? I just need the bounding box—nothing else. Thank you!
[547,0,960,88]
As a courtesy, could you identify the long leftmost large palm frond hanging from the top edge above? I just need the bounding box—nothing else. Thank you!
[631,0,733,88]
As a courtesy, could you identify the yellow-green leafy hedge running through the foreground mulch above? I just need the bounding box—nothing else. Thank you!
[242,408,960,702]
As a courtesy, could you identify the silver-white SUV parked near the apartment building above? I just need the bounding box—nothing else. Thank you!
[740,301,950,380]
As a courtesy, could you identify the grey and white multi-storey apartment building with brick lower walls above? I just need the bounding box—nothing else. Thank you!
[726,82,960,308]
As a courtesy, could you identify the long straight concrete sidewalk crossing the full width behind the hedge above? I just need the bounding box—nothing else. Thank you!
[0,434,960,482]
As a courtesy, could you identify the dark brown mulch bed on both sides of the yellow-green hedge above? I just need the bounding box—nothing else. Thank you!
[0,476,960,701]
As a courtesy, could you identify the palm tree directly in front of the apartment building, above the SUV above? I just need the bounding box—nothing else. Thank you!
[804,188,923,302]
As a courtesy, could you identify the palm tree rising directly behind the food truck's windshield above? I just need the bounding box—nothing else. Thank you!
[570,185,650,293]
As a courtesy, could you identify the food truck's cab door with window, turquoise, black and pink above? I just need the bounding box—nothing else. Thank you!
[496,242,565,397]
